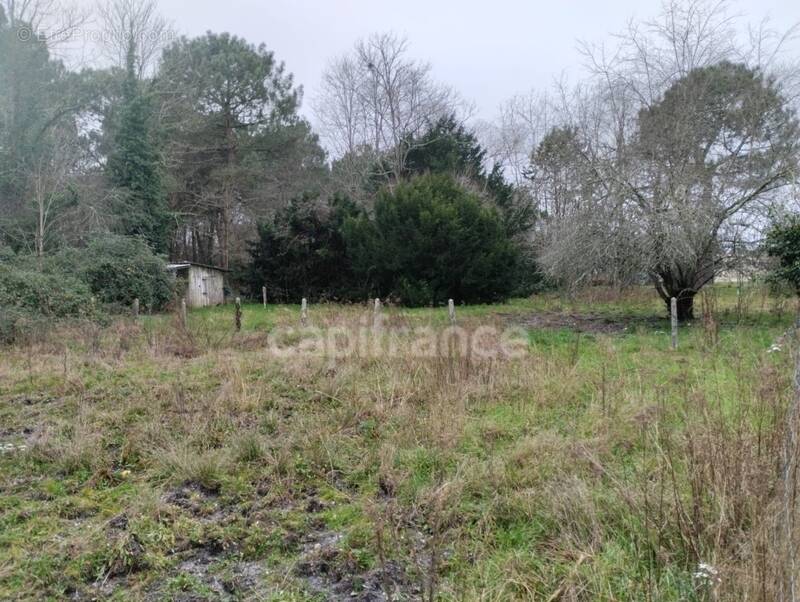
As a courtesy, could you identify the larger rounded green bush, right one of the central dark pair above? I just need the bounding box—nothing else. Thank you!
[345,175,520,305]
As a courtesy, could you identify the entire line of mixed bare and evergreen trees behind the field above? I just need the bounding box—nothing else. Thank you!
[0,0,800,319]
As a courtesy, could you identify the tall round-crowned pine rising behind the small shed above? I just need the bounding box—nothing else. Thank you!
[158,32,318,267]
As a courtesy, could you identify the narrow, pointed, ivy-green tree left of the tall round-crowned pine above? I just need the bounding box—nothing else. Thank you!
[107,43,169,253]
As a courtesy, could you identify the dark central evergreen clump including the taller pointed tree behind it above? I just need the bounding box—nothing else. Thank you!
[245,115,542,305]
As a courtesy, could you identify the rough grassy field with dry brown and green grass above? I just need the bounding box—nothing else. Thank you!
[0,287,796,602]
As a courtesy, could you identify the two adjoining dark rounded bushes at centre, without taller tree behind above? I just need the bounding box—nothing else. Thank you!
[244,175,530,306]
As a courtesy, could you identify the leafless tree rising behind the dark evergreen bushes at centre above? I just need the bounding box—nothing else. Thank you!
[313,34,460,189]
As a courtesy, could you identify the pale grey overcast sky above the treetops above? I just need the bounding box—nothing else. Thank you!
[76,0,800,119]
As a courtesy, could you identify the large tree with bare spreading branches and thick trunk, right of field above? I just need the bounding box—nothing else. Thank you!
[542,0,798,319]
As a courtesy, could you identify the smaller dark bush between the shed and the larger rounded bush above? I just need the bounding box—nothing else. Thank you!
[244,196,362,302]
